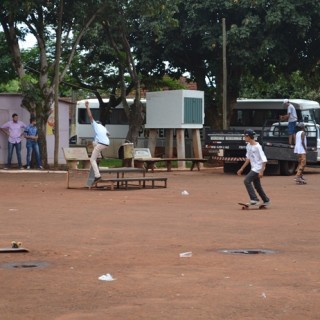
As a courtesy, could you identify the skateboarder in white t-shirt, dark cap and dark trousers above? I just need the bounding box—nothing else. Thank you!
[237,129,270,206]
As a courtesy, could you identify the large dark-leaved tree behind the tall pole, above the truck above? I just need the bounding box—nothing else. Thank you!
[140,0,320,127]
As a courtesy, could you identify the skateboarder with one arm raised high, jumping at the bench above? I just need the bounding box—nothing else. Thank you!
[84,101,110,184]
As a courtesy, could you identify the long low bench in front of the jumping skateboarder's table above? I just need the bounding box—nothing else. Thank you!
[89,177,168,190]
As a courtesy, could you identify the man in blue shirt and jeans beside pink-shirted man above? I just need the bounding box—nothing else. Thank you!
[24,117,43,169]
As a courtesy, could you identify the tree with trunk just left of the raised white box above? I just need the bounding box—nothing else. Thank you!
[68,0,180,143]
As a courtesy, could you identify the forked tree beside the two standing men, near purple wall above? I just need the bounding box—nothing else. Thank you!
[0,0,107,165]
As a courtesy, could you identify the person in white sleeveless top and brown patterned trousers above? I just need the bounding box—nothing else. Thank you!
[293,122,307,182]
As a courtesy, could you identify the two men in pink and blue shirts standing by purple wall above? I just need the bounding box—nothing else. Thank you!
[0,113,43,169]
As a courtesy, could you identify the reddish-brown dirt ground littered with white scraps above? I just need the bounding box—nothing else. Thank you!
[0,168,320,320]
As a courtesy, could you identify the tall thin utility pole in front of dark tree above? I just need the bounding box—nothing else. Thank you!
[222,18,228,130]
